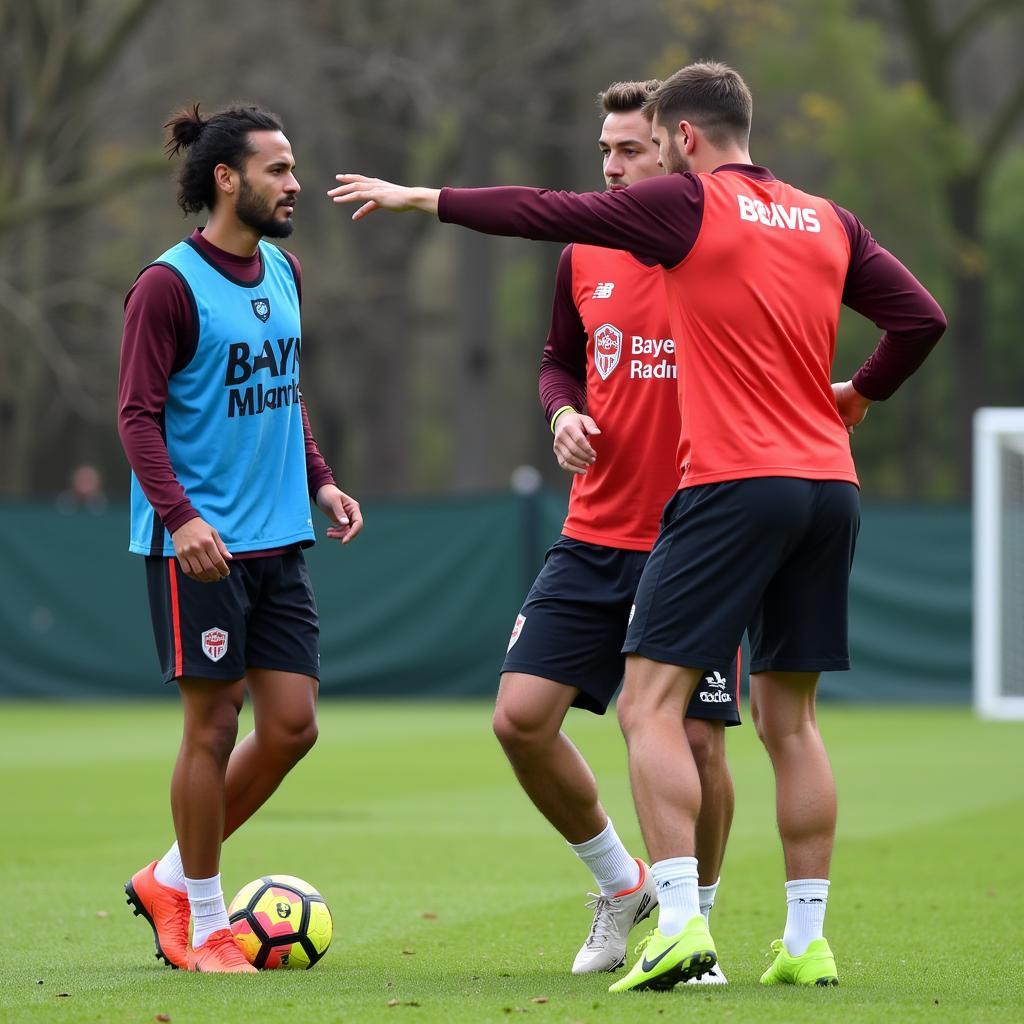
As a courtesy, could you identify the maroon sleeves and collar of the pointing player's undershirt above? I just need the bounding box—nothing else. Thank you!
[437,164,946,401]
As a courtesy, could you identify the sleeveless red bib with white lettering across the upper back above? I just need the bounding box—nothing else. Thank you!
[666,170,857,487]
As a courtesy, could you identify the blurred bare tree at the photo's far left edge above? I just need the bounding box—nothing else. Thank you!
[0,0,162,496]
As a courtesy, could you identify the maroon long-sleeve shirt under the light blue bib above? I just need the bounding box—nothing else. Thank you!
[118,228,335,540]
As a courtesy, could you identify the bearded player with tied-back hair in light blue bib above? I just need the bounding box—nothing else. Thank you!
[119,104,362,973]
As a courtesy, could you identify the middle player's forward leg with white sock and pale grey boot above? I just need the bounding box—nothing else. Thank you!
[493,672,655,974]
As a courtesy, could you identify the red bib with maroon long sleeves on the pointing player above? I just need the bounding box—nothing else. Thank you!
[437,164,946,486]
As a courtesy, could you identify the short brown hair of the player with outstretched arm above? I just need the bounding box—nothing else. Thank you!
[643,60,754,145]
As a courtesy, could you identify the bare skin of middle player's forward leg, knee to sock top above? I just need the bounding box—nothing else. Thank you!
[492,672,608,844]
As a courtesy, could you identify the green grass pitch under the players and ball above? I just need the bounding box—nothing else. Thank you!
[0,703,1024,1024]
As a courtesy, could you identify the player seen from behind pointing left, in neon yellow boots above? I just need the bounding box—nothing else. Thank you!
[329,62,945,991]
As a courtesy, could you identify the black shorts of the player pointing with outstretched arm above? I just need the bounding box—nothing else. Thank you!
[624,476,860,674]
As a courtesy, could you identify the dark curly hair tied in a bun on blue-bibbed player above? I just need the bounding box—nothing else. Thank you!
[164,103,284,213]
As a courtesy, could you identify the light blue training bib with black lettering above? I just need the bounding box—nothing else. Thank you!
[129,240,314,556]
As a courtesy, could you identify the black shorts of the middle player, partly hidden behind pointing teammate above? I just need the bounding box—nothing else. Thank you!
[502,537,739,725]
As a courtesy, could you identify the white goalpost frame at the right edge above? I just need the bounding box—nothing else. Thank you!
[974,409,1024,719]
